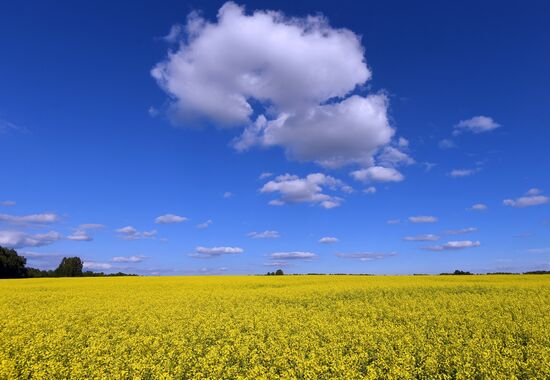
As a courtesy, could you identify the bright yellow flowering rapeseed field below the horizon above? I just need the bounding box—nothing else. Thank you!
[0,275,550,379]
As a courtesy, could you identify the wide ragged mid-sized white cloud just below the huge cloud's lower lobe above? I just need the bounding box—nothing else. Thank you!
[260,173,353,209]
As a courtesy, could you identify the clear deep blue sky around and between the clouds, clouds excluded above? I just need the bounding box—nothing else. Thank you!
[0,1,550,274]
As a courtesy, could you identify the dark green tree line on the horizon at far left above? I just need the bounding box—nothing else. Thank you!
[0,246,135,278]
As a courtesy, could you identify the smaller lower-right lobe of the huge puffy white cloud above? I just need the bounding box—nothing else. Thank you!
[235,95,394,168]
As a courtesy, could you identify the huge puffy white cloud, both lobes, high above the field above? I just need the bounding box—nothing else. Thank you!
[151,2,395,167]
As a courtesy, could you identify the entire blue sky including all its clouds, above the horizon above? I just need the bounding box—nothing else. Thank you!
[0,1,550,274]
